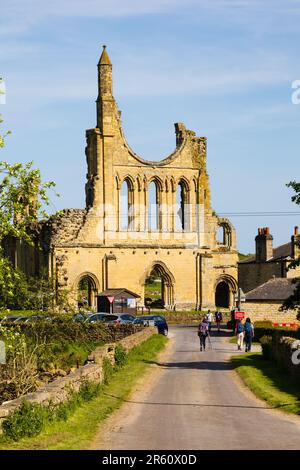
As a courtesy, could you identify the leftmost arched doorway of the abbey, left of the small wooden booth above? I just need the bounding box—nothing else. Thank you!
[75,272,99,311]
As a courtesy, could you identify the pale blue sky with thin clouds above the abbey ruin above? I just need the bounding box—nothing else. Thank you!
[0,0,300,252]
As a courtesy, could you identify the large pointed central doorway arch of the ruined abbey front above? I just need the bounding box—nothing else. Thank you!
[143,261,175,309]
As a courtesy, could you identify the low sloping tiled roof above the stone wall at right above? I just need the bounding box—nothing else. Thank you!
[246,277,295,301]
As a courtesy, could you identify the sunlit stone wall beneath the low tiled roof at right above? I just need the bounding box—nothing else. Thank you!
[242,301,300,325]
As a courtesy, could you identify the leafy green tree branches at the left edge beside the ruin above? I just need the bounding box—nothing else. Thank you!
[0,116,55,308]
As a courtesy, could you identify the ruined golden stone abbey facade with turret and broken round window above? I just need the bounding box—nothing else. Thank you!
[11,46,238,310]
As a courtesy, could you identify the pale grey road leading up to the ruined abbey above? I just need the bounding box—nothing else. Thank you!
[92,327,300,450]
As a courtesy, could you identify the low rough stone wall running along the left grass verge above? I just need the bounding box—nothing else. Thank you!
[0,327,157,433]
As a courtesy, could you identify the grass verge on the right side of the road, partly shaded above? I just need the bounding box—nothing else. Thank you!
[231,353,300,415]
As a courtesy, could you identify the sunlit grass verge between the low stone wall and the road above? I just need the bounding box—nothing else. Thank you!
[0,335,168,450]
